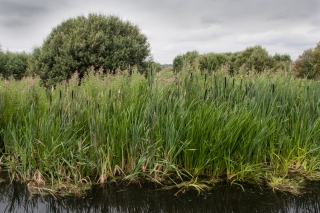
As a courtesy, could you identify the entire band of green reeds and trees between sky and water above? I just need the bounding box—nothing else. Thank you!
[0,14,320,196]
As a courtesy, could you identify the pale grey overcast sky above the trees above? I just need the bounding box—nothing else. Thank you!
[0,0,320,64]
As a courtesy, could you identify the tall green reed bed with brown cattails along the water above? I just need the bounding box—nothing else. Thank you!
[0,67,320,195]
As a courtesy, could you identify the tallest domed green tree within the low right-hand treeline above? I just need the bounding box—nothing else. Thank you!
[234,45,274,72]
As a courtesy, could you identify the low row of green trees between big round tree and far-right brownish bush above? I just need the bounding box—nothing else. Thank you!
[173,45,292,74]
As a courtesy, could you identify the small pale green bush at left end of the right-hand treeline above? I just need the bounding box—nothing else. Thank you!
[172,50,199,72]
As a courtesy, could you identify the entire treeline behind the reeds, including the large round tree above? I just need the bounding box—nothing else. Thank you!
[0,11,320,87]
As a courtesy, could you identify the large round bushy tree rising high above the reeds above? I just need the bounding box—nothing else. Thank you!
[28,14,150,86]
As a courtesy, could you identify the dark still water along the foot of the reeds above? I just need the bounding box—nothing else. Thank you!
[0,176,320,213]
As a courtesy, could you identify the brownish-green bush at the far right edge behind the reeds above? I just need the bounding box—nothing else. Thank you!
[294,42,320,79]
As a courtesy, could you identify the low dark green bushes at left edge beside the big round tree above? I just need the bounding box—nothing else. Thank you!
[0,50,30,79]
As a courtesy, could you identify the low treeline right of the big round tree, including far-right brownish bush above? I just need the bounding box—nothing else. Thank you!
[173,43,320,79]
